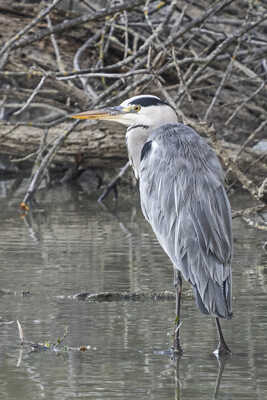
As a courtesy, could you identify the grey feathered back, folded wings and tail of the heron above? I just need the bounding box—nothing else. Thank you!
[139,123,232,319]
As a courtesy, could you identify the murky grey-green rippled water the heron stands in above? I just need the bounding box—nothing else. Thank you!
[0,182,267,400]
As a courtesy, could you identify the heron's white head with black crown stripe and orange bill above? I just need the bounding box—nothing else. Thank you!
[71,95,177,127]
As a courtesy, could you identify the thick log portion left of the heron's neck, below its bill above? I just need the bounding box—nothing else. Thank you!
[0,122,127,168]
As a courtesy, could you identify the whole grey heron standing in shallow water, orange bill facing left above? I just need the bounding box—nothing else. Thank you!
[72,95,232,355]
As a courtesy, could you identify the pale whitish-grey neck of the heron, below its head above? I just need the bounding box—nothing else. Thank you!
[126,125,150,179]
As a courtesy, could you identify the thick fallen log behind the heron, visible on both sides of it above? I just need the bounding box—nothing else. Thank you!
[0,121,267,182]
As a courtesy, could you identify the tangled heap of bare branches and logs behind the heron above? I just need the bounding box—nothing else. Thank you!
[0,0,267,209]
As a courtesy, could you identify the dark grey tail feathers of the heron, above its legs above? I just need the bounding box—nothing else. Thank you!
[193,277,233,319]
